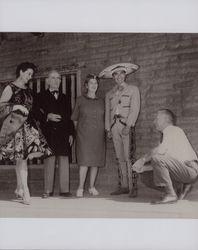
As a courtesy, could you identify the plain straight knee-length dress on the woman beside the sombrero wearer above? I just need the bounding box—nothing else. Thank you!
[71,95,105,167]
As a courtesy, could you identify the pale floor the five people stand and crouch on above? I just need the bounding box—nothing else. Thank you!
[0,187,198,218]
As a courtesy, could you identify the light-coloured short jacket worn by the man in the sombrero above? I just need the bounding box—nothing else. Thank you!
[105,83,140,131]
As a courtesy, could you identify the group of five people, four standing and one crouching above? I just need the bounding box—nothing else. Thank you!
[0,62,198,205]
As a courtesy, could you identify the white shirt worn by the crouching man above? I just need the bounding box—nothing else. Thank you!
[155,125,197,162]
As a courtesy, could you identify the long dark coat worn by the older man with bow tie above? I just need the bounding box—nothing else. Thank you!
[33,90,74,156]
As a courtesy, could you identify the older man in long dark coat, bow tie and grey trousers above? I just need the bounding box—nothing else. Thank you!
[35,70,74,198]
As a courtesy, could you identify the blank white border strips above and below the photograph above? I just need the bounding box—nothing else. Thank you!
[0,0,198,250]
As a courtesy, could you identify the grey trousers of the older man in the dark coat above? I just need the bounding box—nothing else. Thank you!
[44,156,69,193]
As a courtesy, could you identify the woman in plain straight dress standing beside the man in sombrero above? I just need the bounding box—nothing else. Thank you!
[71,75,105,197]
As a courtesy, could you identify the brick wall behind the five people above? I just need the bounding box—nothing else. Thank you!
[0,33,198,191]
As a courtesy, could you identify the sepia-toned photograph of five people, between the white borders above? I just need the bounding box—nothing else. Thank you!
[0,0,198,249]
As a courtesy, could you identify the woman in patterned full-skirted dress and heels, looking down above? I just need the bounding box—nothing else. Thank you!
[0,62,51,205]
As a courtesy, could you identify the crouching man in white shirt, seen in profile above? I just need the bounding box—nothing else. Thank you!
[132,109,198,204]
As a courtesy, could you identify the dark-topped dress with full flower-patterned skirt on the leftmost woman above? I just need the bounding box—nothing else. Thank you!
[0,83,51,162]
